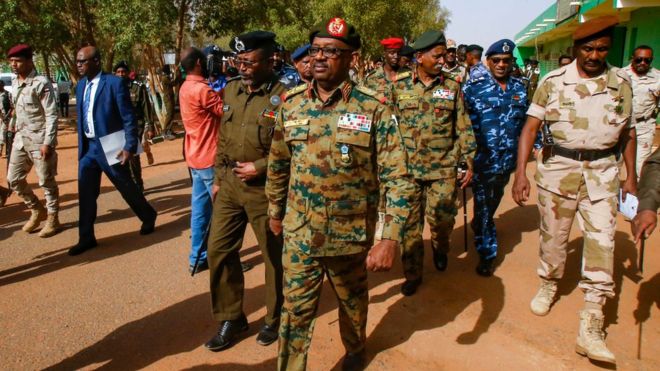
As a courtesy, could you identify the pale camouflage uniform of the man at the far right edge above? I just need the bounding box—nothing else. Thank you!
[623,65,660,177]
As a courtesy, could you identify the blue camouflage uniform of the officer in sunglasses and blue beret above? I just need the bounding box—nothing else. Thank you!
[463,74,528,259]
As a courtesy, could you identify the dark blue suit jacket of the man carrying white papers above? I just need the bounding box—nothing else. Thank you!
[76,72,138,160]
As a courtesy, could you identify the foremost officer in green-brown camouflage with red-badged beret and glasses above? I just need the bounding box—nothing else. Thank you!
[266,18,412,370]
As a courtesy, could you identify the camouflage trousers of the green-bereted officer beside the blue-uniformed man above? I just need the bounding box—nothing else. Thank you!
[401,178,457,280]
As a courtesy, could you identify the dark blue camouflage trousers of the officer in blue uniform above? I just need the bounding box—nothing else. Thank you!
[471,173,511,259]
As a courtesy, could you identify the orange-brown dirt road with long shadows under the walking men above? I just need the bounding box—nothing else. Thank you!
[0,126,660,370]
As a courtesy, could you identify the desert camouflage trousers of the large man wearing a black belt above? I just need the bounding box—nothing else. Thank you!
[537,178,617,305]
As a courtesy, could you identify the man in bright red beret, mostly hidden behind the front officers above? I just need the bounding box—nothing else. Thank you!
[363,37,408,98]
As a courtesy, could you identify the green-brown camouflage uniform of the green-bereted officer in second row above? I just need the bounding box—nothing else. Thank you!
[393,72,476,280]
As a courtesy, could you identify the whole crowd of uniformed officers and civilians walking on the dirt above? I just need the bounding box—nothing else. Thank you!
[0,13,660,370]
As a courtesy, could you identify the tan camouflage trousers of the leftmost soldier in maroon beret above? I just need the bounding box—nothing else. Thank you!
[7,147,59,214]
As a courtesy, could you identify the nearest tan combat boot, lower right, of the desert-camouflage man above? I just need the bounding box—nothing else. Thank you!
[575,309,616,363]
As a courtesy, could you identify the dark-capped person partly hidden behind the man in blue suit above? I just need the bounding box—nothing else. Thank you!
[113,61,154,192]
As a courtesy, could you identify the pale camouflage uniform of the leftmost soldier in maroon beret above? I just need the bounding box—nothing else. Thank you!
[7,70,59,214]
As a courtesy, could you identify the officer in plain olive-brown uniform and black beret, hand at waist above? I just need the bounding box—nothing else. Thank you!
[206,31,284,351]
